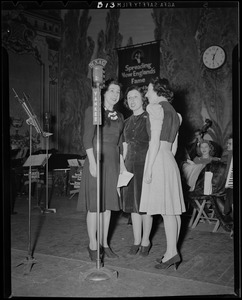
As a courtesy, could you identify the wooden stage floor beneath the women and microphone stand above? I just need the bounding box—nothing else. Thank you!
[8,194,238,297]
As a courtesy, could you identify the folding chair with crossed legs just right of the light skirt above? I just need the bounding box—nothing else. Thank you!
[188,193,220,232]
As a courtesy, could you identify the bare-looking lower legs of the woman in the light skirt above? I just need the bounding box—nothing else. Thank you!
[162,215,180,262]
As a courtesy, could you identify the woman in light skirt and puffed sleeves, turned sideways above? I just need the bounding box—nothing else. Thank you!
[139,78,186,269]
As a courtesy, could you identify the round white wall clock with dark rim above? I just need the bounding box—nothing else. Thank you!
[203,46,226,70]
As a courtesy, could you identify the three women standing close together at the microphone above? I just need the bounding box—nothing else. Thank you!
[78,78,185,269]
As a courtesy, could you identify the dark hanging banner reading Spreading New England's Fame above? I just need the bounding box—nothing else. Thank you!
[117,41,160,117]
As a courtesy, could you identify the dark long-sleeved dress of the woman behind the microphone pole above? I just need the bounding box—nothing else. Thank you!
[77,107,124,212]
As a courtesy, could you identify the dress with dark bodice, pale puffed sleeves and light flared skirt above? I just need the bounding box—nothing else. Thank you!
[139,101,186,215]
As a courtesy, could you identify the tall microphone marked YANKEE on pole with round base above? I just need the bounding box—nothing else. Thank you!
[80,59,118,281]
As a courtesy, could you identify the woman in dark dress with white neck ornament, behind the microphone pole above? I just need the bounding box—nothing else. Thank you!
[77,79,124,261]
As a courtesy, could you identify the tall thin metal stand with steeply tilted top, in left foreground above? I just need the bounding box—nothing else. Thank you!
[12,89,52,275]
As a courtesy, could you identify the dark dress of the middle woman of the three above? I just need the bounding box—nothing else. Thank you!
[122,112,149,213]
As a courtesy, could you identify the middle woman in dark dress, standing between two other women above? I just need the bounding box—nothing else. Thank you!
[122,86,153,256]
